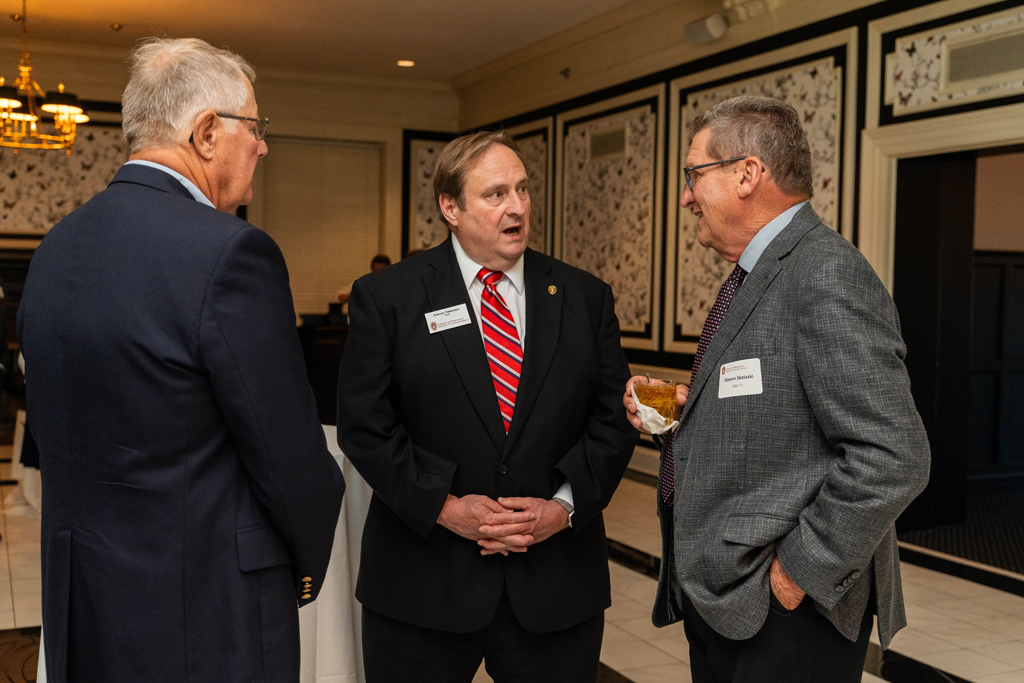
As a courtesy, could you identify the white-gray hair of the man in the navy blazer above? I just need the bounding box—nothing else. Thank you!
[121,38,256,153]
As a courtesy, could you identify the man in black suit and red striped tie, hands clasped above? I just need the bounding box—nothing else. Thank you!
[338,133,637,683]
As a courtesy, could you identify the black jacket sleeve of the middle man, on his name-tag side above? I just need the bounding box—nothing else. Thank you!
[338,280,458,539]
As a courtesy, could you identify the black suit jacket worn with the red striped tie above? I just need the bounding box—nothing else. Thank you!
[338,239,637,632]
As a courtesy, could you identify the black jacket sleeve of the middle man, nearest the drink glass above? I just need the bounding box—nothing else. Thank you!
[555,284,640,532]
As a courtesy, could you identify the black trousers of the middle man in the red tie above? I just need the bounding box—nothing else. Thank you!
[362,592,604,683]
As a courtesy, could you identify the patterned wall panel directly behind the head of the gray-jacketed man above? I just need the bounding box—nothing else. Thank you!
[665,40,846,353]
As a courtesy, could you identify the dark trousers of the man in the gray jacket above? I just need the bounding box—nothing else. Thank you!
[680,592,872,683]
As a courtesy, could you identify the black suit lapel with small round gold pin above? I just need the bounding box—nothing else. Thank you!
[502,249,565,458]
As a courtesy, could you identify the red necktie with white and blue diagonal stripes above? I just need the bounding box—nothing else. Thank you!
[476,268,522,433]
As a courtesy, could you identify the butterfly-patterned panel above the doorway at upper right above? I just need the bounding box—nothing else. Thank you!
[884,8,1024,117]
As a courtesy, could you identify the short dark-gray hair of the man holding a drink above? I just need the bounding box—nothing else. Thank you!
[690,95,814,196]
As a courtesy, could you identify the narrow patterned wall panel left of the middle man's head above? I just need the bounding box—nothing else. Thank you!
[402,133,455,253]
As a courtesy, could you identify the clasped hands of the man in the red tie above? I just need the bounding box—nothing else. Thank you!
[437,495,569,555]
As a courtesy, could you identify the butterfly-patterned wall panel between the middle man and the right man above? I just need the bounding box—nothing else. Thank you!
[558,86,664,349]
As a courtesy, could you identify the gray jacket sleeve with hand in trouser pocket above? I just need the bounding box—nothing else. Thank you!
[776,248,931,609]
